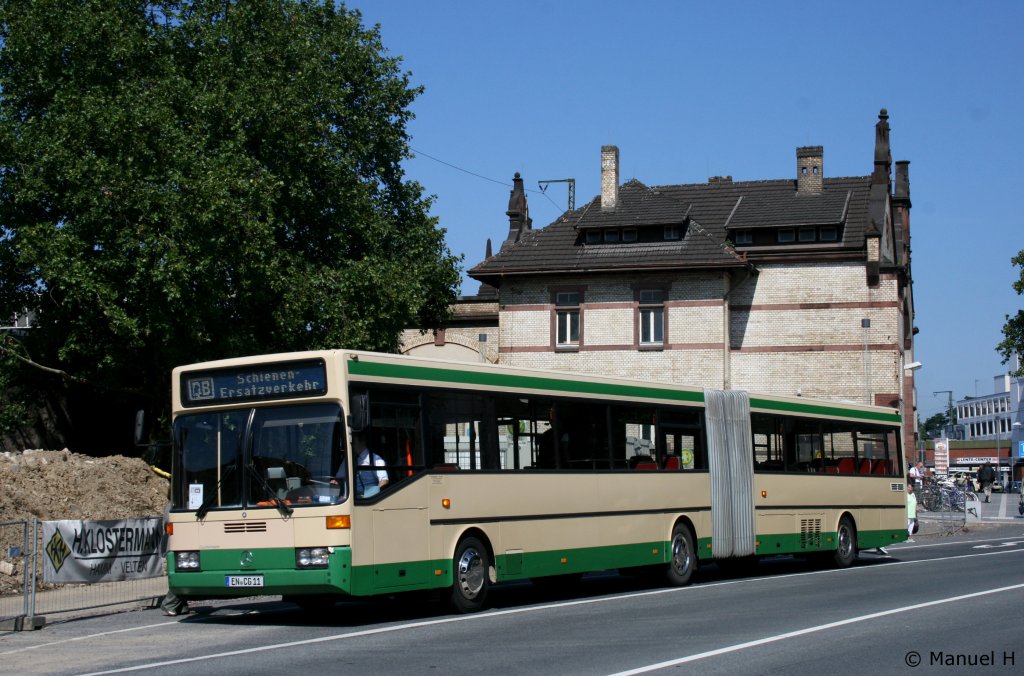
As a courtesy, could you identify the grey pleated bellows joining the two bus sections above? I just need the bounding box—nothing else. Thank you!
[705,389,755,558]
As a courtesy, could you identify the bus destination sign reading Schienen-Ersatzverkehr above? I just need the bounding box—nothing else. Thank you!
[181,360,327,406]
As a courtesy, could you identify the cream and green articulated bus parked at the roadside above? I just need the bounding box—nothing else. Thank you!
[167,350,907,612]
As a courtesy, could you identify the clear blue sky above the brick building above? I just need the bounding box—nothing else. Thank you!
[348,0,1024,417]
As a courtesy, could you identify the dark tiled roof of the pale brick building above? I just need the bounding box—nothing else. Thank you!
[469,176,870,284]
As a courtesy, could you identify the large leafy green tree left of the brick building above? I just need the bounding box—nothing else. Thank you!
[0,0,461,450]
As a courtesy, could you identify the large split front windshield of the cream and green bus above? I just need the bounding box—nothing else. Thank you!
[171,404,347,510]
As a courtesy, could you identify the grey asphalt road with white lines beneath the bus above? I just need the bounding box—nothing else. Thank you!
[0,522,1024,676]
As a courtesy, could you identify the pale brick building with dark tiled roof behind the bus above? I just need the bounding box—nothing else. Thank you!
[404,110,915,449]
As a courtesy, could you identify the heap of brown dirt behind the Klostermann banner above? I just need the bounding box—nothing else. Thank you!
[0,449,168,593]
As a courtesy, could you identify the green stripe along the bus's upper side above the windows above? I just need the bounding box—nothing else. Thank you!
[347,360,900,423]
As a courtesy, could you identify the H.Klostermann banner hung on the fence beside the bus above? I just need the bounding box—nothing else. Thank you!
[43,516,164,584]
